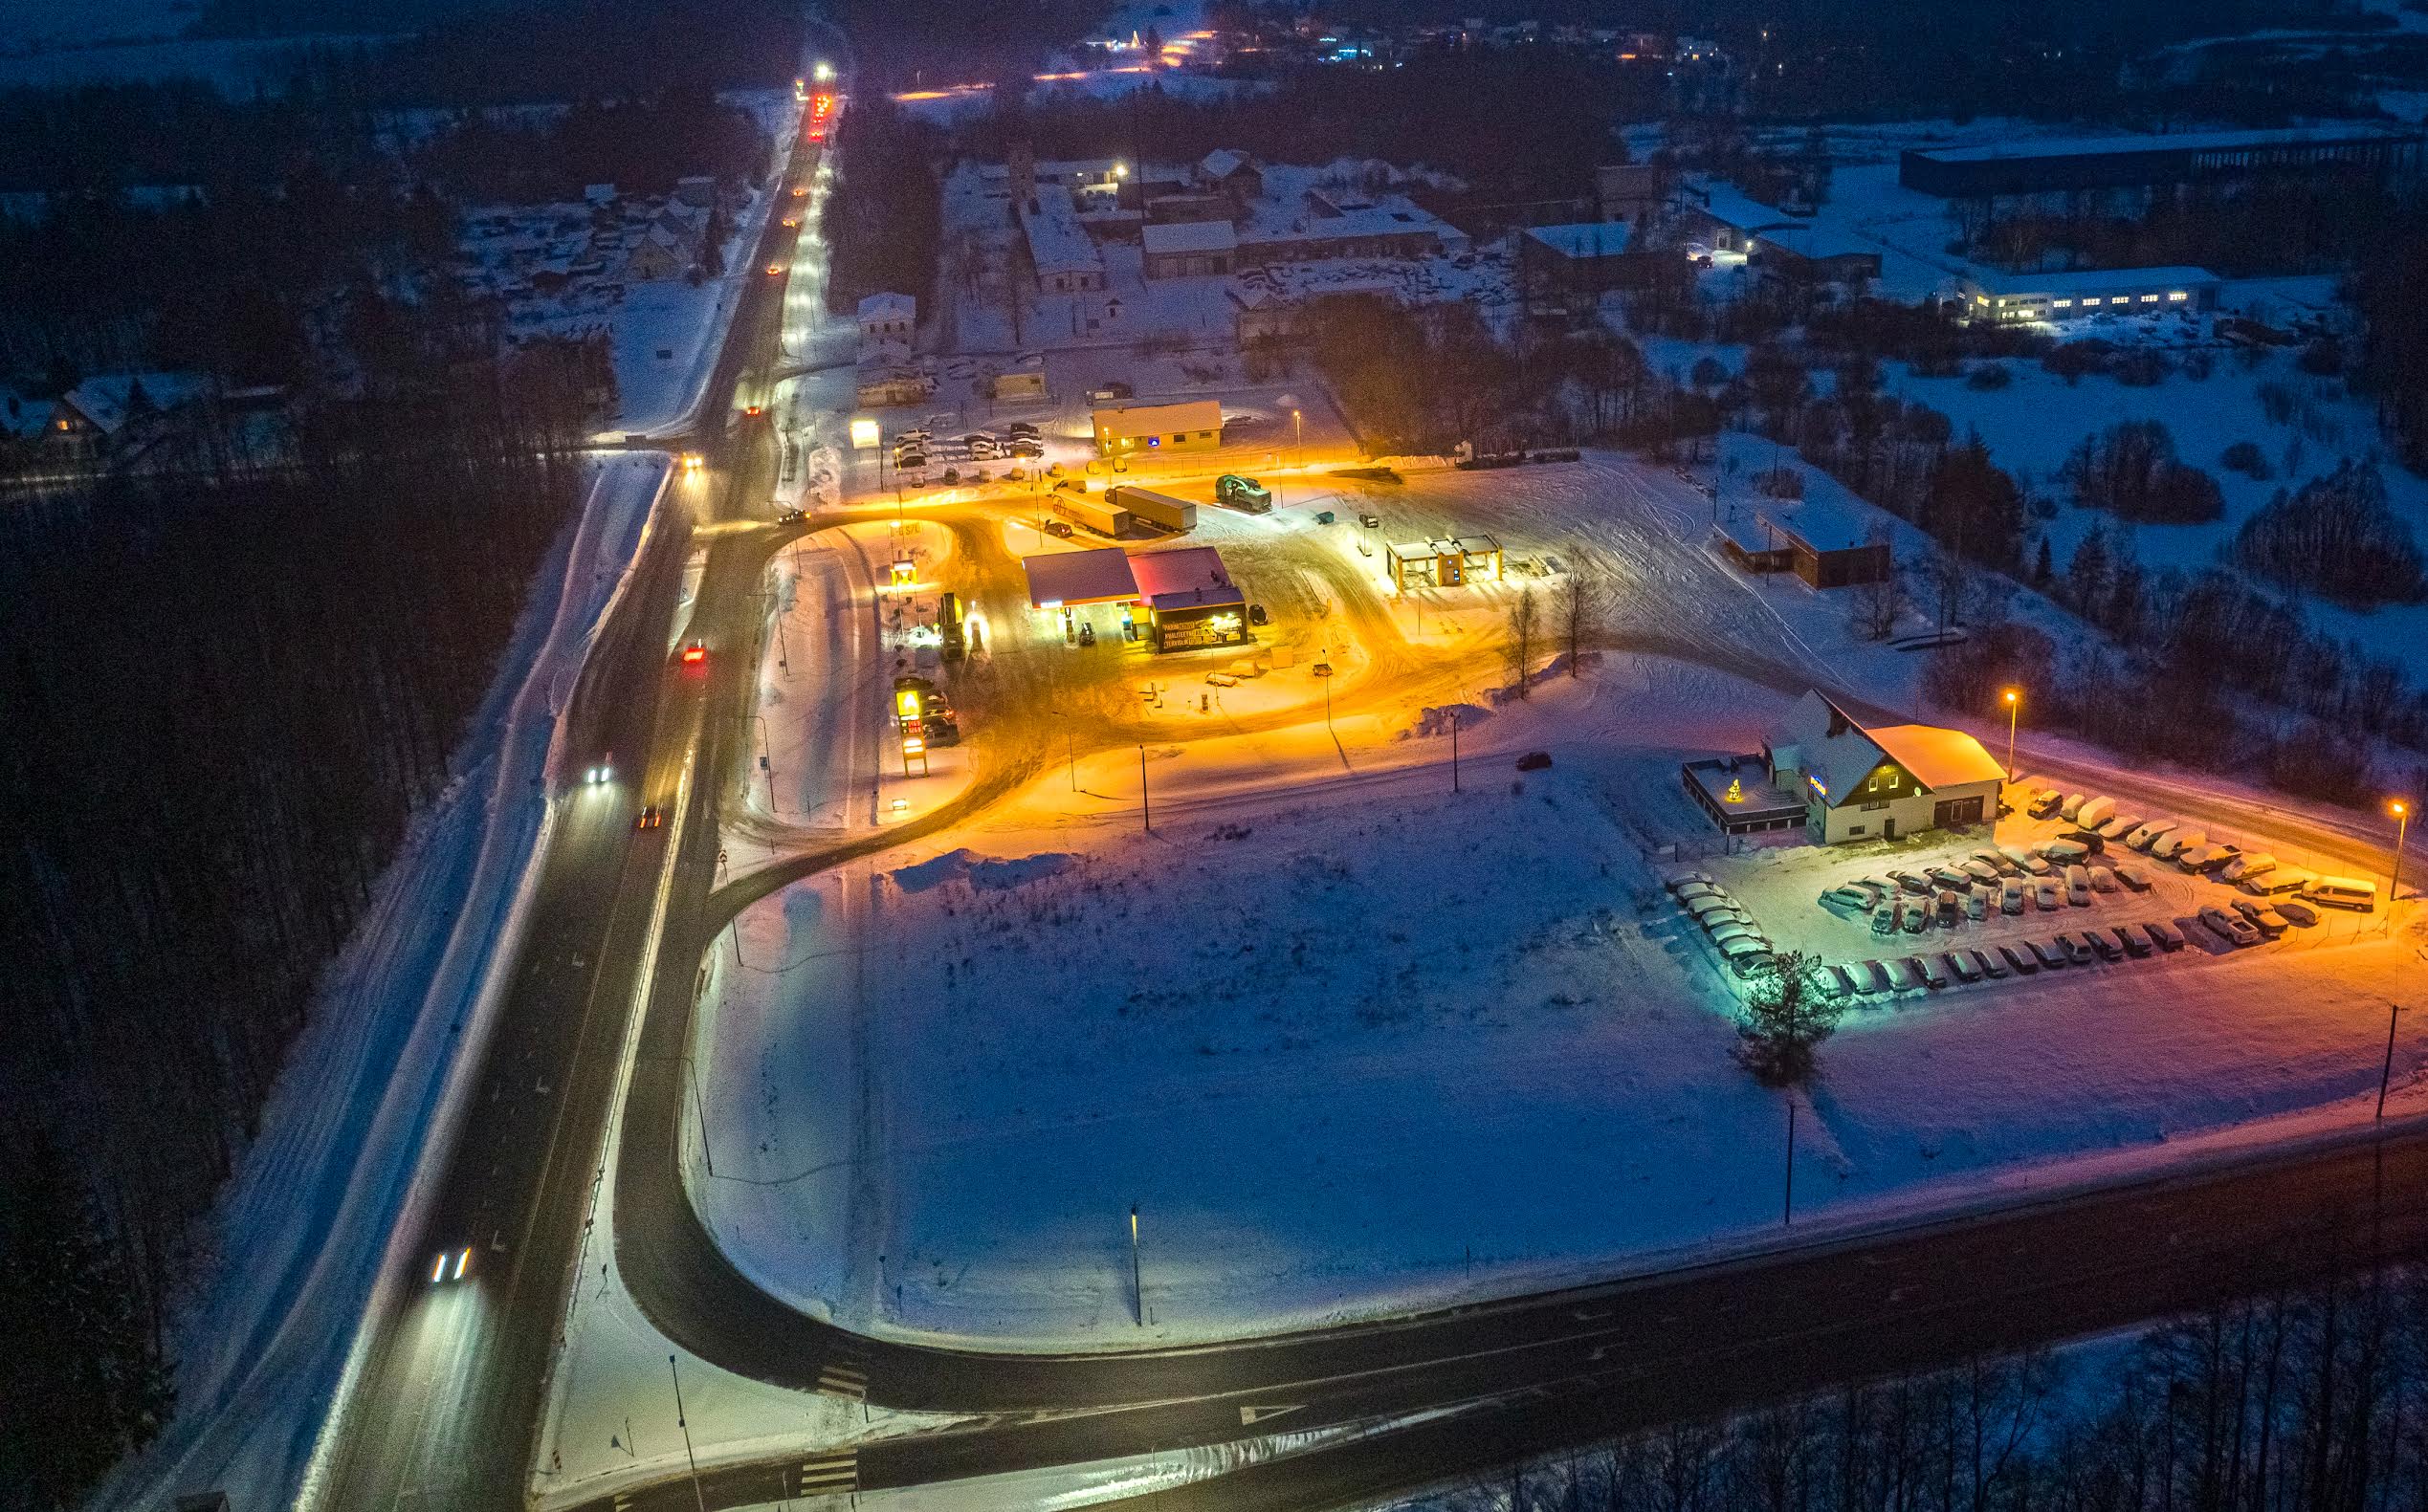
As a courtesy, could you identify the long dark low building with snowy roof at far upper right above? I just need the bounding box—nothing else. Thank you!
[1896,123,2428,199]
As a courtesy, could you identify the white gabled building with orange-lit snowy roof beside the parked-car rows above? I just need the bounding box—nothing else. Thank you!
[1763,691,2005,844]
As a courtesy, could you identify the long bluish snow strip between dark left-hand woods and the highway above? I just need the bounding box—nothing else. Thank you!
[98,456,665,1507]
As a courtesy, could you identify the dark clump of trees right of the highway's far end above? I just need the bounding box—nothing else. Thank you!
[823,98,944,316]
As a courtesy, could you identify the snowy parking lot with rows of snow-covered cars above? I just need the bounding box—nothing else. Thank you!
[1666,777,2379,1000]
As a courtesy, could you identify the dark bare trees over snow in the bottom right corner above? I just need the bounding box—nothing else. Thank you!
[1427,1269,2428,1512]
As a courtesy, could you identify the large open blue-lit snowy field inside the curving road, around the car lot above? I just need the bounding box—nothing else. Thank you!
[695,658,2428,1347]
